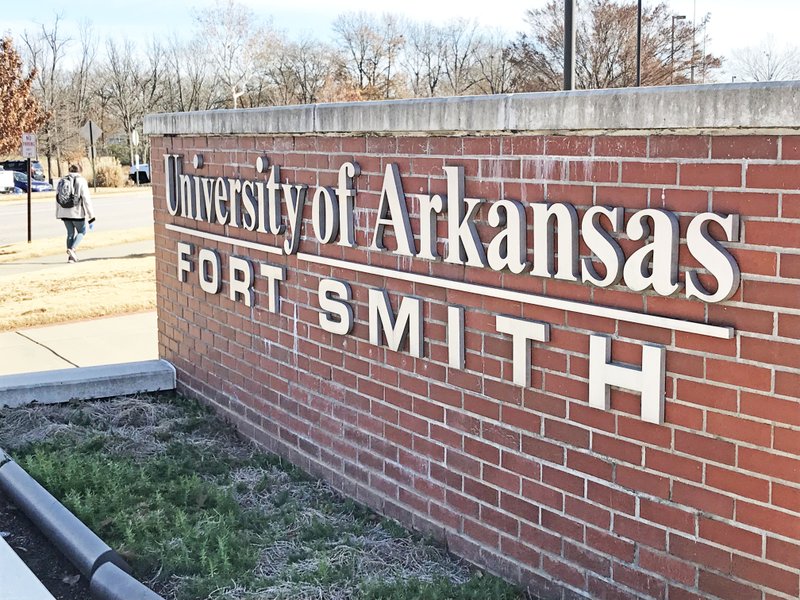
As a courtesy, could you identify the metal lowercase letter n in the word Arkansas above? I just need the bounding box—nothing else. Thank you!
[531,202,578,281]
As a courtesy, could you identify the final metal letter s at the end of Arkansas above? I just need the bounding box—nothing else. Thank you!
[686,213,741,302]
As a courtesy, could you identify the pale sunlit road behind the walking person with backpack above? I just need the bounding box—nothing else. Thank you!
[0,188,153,246]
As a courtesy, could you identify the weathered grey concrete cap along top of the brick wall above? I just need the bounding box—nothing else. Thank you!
[144,81,800,135]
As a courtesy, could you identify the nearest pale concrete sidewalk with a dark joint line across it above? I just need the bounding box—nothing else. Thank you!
[0,312,158,375]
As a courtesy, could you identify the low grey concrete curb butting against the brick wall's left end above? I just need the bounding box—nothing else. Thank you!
[0,360,175,408]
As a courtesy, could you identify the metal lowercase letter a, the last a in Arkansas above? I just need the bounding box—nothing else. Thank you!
[623,208,681,296]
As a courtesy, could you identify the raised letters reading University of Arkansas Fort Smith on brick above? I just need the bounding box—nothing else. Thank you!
[164,154,740,423]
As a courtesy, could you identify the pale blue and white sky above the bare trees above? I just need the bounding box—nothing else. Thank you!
[0,0,800,77]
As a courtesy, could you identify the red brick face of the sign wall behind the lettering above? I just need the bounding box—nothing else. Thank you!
[152,135,800,600]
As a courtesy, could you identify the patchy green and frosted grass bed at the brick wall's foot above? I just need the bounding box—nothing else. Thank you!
[0,396,523,600]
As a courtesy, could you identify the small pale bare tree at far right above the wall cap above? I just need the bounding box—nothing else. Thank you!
[730,35,800,81]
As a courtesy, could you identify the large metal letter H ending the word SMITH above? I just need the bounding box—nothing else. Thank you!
[589,335,666,425]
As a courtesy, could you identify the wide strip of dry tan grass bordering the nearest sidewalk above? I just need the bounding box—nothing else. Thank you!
[0,254,156,331]
